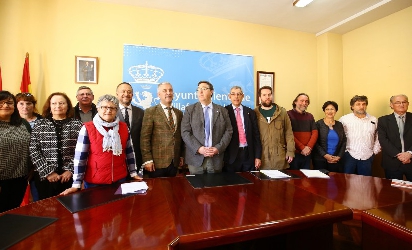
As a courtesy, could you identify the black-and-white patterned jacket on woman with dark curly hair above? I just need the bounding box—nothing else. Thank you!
[30,118,83,180]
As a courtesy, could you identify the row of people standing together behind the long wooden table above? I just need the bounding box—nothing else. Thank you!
[0,81,412,212]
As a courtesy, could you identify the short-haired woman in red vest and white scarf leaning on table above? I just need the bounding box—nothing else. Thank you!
[62,95,142,195]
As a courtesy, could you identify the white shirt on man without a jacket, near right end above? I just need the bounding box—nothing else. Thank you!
[339,113,381,160]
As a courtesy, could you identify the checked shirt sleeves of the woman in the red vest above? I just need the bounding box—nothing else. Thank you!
[72,126,137,188]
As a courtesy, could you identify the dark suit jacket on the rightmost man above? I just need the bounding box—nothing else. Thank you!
[378,112,412,169]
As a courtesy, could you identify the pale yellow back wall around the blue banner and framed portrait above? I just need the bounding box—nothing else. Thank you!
[0,0,317,115]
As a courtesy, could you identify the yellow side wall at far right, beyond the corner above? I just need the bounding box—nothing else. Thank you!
[342,7,412,117]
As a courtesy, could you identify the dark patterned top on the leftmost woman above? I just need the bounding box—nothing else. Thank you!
[0,121,30,180]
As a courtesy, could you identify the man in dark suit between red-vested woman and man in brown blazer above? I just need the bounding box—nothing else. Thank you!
[116,82,144,173]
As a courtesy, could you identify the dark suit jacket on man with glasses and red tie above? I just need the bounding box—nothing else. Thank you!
[224,104,262,165]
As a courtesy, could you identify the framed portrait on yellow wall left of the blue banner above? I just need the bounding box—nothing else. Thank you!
[75,56,98,83]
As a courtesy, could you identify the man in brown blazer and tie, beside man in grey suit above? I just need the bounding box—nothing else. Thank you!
[140,82,183,178]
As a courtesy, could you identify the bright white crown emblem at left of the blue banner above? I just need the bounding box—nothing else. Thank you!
[129,61,164,84]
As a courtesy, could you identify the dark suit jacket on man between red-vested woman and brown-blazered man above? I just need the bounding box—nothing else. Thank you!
[117,105,144,172]
